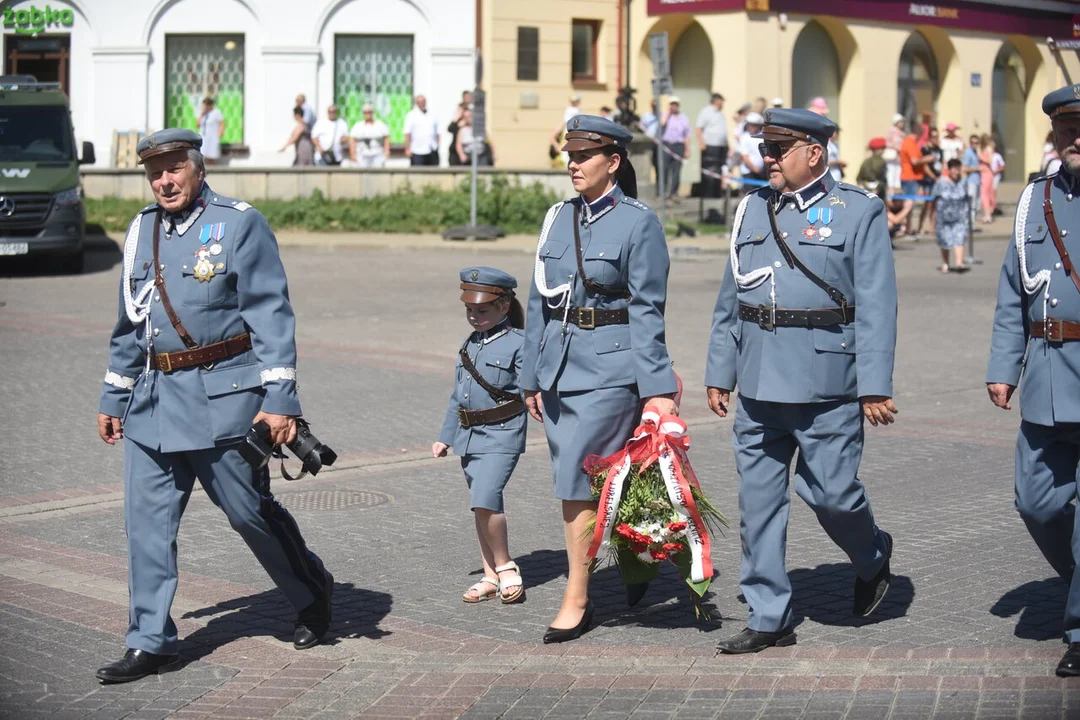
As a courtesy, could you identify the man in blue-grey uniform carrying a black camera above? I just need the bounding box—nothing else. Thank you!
[97,128,334,682]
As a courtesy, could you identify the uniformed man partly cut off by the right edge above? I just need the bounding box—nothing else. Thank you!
[986,85,1080,677]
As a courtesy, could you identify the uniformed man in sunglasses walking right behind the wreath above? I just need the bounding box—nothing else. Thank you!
[705,109,897,653]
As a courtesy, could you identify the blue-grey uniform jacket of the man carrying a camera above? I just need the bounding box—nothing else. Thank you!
[99,185,300,452]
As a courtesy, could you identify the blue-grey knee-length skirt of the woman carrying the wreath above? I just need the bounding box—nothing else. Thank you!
[542,385,642,500]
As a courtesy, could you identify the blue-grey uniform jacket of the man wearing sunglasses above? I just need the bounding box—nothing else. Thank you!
[705,173,896,403]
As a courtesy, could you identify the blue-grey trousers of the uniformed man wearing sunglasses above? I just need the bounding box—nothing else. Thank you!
[733,395,886,633]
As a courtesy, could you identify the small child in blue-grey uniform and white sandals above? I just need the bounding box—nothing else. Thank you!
[431,268,526,603]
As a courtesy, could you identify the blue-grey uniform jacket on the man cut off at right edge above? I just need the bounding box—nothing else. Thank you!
[986,172,1080,425]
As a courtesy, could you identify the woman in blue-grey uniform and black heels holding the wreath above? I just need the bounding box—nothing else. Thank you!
[518,116,677,642]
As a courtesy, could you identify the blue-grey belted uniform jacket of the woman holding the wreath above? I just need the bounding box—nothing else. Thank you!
[519,186,676,397]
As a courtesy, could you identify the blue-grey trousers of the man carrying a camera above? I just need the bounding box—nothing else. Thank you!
[124,439,327,655]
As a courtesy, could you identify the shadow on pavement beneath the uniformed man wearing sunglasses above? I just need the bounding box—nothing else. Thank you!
[788,562,915,627]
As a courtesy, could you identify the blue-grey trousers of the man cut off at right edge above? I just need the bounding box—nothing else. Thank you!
[1015,421,1080,642]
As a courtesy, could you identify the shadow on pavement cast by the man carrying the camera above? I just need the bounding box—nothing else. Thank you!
[181,583,393,662]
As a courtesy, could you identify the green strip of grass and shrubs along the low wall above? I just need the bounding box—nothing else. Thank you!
[86,176,559,233]
